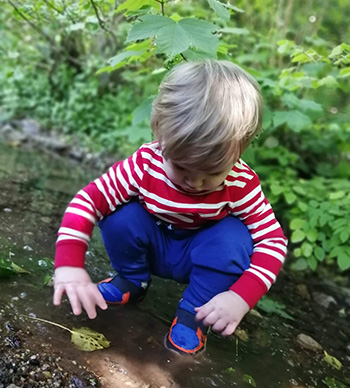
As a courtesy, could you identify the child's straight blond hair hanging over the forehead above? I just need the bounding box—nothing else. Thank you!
[151,60,263,170]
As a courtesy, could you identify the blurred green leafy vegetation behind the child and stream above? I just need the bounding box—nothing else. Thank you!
[0,0,350,273]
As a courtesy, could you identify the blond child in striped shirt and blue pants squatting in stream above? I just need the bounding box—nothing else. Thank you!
[54,60,286,354]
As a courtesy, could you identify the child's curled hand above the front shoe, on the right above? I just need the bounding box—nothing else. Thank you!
[195,291,249,336]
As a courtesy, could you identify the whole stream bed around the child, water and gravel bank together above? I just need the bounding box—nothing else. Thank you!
[0,143,350,388]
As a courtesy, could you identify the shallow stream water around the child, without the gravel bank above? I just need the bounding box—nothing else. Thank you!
[0,144,350,388]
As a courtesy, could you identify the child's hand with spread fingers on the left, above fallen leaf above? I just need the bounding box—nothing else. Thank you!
[53,267,107,319]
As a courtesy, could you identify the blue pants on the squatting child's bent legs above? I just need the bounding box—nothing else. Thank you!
[99,201,253,306]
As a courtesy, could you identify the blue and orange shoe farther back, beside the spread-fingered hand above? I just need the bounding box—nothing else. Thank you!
[97,275,150,304]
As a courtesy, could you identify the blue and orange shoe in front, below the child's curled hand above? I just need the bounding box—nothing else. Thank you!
[165,299,208,355]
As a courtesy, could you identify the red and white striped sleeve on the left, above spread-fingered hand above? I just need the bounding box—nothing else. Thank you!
[55,149,143,268]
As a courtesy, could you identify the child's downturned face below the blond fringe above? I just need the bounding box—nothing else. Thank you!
[164,159,234,194]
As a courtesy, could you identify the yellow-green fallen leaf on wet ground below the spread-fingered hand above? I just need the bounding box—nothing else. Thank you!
[71,327,111,352]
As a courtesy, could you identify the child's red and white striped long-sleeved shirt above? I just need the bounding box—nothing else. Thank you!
[55,142,287,307]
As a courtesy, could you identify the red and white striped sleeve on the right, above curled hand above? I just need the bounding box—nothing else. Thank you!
[229,169,287,308]
